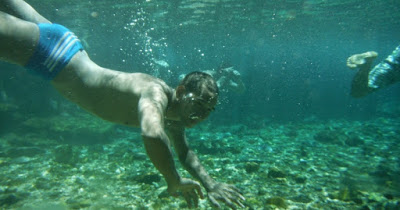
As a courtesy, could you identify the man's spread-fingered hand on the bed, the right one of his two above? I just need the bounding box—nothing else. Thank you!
[208,182,245,209]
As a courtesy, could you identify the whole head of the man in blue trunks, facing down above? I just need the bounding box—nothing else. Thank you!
[176,71,218,127]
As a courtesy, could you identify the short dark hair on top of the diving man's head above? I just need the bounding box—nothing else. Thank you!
[180,71,219,95]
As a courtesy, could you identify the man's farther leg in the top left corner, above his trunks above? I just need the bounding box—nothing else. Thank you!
[0,0,51,24]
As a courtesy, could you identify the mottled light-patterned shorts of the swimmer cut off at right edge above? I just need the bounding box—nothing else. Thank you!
[368,46,400,90]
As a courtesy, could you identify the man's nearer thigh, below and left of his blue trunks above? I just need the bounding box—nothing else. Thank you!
[0,11,39,66]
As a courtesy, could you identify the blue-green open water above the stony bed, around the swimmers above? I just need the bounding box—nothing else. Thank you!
[0,0,400,208]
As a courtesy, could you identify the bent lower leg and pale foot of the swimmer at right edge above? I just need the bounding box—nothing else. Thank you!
[347,51,378,98]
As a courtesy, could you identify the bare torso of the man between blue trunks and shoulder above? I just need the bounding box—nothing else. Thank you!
[52,52,173,127]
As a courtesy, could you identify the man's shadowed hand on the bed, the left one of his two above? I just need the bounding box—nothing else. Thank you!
[168,178,204,208]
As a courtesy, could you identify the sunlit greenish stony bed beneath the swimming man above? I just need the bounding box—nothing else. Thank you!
[0,101,400,209]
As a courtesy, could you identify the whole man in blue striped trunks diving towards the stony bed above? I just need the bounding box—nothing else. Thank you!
[0,0,244,208]
